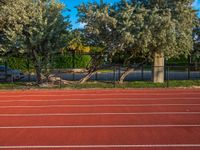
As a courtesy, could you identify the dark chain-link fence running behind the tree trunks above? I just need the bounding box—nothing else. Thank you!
[0,54,200,88]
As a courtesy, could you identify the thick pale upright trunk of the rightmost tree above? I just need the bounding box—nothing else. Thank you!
[152,52,165,83]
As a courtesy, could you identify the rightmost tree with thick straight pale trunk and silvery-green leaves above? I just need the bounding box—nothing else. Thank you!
[144,0,195,82]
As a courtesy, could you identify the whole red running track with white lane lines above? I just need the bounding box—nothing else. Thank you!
[0,89,200,150]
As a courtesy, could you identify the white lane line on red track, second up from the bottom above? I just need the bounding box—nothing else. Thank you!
[0,124,200,129]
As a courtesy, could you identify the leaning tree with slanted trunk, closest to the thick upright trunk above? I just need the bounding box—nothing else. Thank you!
[113,0,152,83]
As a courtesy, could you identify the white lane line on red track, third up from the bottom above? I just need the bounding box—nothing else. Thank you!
[0,112,200,117]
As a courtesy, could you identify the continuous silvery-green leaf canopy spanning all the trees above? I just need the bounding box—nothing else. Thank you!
[0,0,199,83]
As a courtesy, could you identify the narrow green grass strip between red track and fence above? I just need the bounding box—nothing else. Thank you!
[0,80,200,89]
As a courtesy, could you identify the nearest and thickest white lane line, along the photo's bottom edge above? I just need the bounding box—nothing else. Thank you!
[0,144,200,149]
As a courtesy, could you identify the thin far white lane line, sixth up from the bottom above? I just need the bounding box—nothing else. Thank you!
[0,92,200,98]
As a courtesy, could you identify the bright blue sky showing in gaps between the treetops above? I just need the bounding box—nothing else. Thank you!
[60,0,200,28]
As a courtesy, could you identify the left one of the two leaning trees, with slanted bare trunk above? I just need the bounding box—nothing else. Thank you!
[78,1,119,83]
